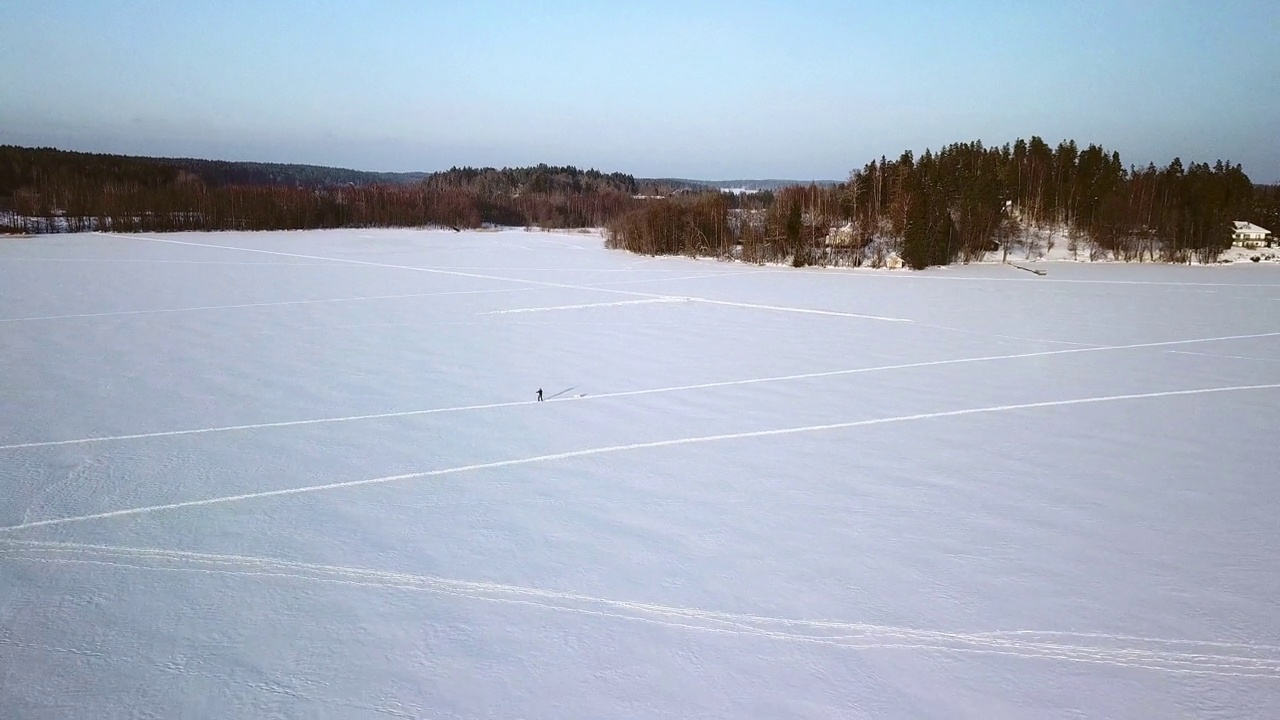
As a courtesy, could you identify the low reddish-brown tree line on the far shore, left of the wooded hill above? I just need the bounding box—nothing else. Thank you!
[0,146,655,232]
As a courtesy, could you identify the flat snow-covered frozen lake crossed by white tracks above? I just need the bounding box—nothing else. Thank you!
[0,231,1280,720]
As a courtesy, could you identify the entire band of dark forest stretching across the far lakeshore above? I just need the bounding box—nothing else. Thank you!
[0,137,1280,268]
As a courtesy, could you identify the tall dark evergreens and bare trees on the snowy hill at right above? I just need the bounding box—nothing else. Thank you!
[608,137,1280,268]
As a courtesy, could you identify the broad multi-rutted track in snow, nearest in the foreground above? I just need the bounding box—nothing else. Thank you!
[0,538,1280,679]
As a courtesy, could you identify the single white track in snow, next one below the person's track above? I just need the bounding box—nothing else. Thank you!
[0,383,1280,533]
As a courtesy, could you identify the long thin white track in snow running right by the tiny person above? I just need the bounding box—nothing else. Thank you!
[0,332,1280,451]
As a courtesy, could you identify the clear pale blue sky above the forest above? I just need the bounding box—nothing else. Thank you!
[0,0,1280,182]
